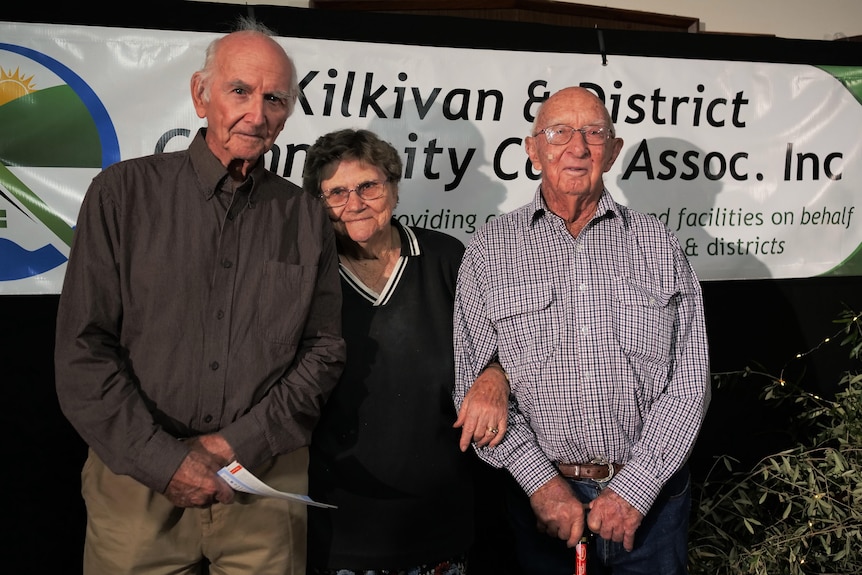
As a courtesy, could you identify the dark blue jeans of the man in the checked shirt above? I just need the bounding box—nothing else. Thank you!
[506,466,691,575]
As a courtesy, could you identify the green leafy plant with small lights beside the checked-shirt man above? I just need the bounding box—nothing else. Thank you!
[689,311,862,575]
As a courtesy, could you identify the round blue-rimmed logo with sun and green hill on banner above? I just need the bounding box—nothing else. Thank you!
[0,43,120,286]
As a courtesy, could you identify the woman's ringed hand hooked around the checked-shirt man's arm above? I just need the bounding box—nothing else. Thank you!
[452,364,509,451]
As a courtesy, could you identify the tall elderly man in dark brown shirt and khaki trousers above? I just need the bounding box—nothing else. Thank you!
[56,18,345,575]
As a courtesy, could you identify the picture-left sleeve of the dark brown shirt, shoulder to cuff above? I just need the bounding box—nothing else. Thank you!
[54,187,187,491]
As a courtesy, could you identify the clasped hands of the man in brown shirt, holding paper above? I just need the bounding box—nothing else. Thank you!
[165,435,234,507]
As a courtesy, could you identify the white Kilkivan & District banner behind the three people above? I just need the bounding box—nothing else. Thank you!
[0,22,862,294]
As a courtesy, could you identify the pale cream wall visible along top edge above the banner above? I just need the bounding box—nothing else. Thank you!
[208,0,862,40]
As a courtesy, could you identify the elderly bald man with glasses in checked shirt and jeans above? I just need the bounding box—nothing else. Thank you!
[454,87,710,575]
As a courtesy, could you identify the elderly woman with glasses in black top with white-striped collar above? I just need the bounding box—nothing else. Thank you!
[303,130,509,575]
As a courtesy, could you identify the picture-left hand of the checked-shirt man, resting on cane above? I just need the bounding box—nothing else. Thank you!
[530,475,585,547]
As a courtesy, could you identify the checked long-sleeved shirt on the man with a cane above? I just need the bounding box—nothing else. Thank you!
[454,190,710,514]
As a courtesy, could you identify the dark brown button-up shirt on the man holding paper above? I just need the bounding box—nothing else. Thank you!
[55,130,345,491]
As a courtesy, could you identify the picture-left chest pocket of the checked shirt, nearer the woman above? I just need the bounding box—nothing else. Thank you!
[488,283,561,379]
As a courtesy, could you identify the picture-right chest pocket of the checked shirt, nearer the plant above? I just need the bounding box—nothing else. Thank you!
[613,278,676,364]
